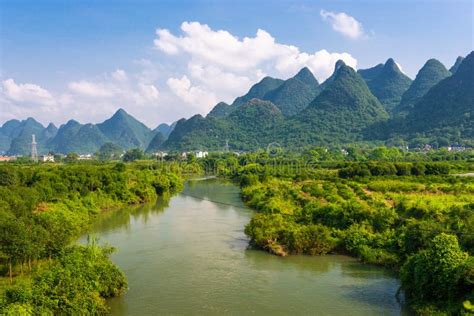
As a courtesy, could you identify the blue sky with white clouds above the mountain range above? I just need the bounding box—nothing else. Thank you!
[0,0,474,128]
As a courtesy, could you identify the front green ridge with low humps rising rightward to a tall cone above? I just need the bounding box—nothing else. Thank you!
[163,64,388,150]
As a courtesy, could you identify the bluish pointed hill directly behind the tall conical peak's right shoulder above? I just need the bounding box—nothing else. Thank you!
[359,58,412,113]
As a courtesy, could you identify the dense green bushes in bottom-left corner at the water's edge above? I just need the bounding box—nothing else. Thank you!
[0,244,127,315]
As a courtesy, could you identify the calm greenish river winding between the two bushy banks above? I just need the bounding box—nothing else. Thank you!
[82,180,406,316]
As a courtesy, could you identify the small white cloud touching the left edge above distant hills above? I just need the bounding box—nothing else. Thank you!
[2,78,56,105]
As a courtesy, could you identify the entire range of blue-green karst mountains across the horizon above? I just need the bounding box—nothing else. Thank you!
[0,52,474,155]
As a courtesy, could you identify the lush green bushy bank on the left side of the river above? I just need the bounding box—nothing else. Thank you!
[0,163,189,314]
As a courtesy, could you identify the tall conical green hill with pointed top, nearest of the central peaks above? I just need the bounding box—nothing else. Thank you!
[279,65,388,147]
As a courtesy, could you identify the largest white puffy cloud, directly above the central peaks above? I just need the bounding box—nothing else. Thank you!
[154,22,357,112]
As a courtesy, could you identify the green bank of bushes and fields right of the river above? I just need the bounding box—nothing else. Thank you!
[228,159,474,314]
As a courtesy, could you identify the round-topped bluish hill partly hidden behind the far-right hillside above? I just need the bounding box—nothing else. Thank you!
[394,59,451,114]
